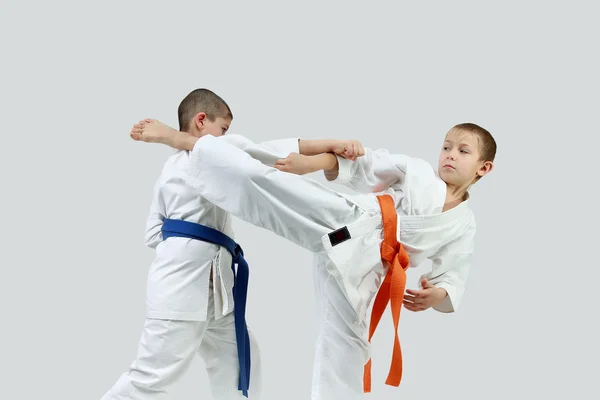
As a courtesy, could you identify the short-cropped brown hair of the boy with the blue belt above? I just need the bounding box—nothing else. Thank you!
[177,89,233,132]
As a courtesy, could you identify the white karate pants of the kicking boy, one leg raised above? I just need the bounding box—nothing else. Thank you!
[189,137,385,400]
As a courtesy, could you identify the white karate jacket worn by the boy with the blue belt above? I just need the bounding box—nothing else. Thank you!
[145,135,299,321]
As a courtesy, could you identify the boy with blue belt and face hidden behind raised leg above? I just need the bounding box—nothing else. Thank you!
[102,89,298,400]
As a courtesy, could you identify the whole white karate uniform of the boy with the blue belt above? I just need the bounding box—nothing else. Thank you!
[102,138,299,400]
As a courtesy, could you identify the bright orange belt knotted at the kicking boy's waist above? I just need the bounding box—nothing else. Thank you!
[363,195,410,393]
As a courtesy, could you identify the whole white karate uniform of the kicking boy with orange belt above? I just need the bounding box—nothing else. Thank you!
[180,135,475,400]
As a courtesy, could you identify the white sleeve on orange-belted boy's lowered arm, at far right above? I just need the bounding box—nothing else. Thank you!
[419,229,475,313]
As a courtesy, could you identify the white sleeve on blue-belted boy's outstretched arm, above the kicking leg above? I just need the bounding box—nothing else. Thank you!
[218,134,300,167]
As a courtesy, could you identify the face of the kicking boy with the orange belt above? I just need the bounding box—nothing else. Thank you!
[438,131,491,187]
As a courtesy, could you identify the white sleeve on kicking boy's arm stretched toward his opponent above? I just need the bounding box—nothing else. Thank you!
[330,148,410,193]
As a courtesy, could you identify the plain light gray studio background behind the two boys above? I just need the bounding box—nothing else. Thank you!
[0,1,600,400]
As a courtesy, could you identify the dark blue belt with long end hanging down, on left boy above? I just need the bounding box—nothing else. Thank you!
[162,219,250,397]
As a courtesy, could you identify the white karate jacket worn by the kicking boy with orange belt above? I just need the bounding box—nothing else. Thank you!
[323,148,476,314]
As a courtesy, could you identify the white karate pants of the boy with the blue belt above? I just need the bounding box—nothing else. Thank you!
[102,283,261,400]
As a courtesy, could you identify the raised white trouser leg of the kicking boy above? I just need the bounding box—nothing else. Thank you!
[189,136,364,252]
